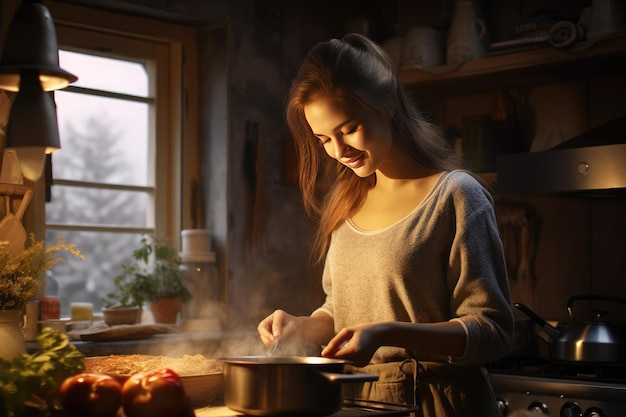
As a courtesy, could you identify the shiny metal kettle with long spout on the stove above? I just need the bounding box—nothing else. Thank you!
[515,294,626,363]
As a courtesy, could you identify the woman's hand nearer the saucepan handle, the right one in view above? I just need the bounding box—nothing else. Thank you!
[322,323,382,366]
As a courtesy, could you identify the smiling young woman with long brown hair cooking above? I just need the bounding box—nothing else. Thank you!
[258,34,513,417]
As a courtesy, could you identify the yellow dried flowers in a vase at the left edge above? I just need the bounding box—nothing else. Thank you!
[0,233,83,357]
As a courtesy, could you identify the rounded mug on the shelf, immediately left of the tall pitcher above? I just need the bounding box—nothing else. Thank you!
[401,26,446,68]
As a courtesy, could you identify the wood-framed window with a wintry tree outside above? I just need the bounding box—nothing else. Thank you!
[46,4,194,316]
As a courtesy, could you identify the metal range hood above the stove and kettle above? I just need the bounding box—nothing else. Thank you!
[496,117,626,197]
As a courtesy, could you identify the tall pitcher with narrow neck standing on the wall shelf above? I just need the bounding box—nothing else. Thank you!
[446,0,485,65]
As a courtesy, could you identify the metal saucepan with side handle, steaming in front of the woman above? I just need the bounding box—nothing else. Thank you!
[220,356,378,416]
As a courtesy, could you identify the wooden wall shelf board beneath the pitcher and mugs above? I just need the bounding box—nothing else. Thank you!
[399,34,626,98]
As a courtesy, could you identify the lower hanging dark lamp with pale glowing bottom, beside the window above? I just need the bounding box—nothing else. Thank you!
[6,71,61,181]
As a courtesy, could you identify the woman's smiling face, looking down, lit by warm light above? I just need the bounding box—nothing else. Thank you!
[304,95,392,178]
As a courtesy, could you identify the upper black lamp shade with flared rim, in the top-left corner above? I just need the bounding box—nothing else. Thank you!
[0,0,78,91]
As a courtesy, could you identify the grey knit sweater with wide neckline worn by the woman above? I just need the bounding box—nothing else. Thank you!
[320,170,514,365]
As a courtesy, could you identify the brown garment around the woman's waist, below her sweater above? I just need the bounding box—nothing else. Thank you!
[343,359,502,417]
